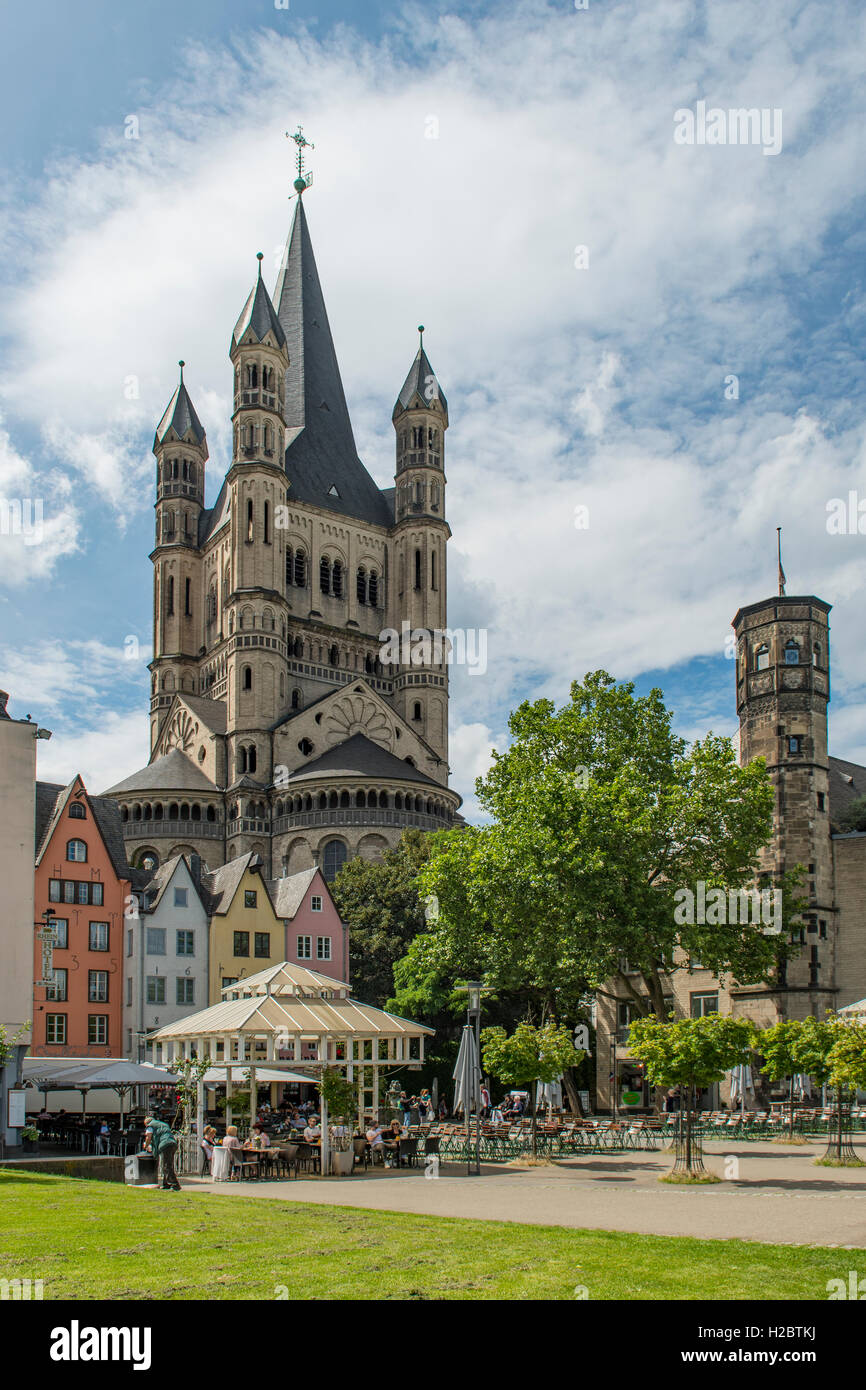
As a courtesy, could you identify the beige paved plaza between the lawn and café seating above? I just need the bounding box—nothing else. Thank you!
[183,1141,866,1248]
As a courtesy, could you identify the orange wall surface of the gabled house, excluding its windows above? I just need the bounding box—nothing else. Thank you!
[32,798,129,1058]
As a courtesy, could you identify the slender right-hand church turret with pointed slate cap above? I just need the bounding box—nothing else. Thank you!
[391,325,450,766]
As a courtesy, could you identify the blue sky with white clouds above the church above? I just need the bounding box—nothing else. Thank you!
[0,0,866,815]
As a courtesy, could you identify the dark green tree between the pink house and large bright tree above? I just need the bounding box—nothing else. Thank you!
[331,830,431,1008]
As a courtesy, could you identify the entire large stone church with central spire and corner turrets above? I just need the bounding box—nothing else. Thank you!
[107,196,460,878]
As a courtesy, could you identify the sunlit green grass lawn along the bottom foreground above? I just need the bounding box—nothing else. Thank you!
[0,1169,844,1300]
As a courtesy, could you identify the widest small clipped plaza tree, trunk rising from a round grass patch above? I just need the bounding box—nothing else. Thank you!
[628,1013,755,1176]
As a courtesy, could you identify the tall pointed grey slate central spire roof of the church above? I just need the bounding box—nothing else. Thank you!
[274,197,393,527]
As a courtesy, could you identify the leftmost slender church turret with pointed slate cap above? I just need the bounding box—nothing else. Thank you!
[150,361,207,748]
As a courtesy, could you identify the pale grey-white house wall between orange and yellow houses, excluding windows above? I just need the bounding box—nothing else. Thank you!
[124,860,210,1061]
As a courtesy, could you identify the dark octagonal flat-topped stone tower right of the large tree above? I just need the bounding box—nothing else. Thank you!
[733,594,835,1017]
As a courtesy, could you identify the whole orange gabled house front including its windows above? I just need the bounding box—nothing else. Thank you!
[31,777,131,1058]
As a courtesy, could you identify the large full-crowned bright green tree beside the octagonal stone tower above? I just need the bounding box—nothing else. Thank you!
[416,671,799,1039]
